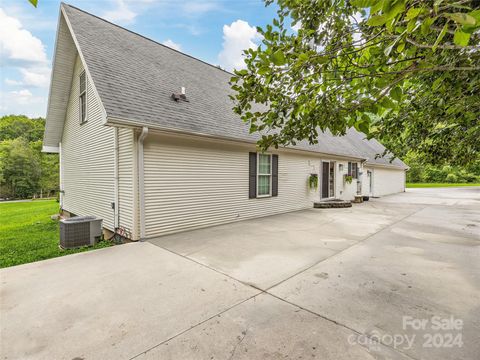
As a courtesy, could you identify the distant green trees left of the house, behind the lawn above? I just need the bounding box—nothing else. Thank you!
[0,115,59,199]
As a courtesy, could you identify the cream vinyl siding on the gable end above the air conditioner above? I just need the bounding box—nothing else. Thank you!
[62,56,115,230]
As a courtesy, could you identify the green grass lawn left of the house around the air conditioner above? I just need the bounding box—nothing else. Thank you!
[0,200,110,268]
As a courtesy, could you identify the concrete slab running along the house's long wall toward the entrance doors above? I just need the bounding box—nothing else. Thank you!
[150,203,418,290]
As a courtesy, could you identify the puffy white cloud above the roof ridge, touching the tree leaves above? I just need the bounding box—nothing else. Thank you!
[218,20,260,70]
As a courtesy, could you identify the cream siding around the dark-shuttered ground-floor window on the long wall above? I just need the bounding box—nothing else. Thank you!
[145,135,320,237]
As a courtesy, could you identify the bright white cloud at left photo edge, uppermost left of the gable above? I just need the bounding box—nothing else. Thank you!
[0,8,47,63]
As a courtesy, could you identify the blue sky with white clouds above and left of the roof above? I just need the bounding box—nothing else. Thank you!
[0,0,275,117]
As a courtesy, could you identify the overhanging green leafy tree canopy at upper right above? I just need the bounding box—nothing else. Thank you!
[231,0,480,164]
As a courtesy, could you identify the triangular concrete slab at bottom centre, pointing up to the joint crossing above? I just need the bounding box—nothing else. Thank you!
[138,294,409,360]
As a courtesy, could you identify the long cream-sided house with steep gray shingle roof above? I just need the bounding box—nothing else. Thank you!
[43,4,406,240]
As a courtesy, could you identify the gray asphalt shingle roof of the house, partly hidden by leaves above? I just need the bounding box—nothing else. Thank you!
[63,4,405,167]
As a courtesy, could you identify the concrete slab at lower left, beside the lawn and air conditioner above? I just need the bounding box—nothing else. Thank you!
[0,243,258,359]
